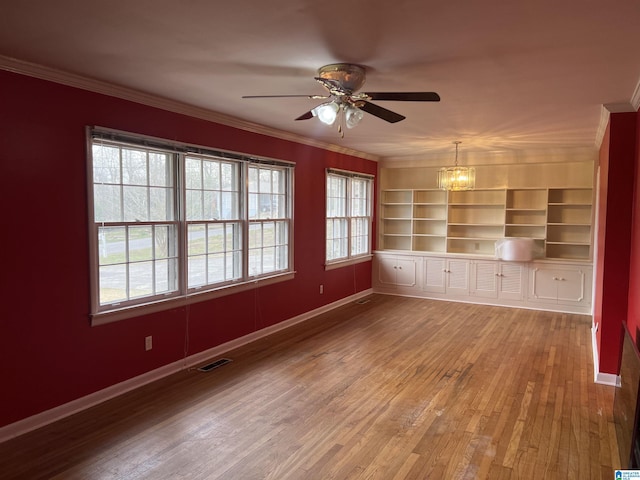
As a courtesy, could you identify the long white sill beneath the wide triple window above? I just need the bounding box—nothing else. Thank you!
[91,272,295,326]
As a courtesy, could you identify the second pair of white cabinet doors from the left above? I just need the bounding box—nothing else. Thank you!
[423,257,470,295]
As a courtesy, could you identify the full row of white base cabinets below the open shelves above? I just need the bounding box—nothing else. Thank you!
[373,252,593,314]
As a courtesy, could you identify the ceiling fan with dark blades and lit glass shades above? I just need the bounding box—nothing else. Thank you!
[242,63,440,136]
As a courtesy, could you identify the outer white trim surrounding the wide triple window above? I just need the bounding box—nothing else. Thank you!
[86,126,296,326]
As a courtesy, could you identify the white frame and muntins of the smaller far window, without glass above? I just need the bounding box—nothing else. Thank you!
[325,168,375,270]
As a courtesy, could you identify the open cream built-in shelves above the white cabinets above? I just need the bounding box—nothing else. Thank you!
[380,188,593,260]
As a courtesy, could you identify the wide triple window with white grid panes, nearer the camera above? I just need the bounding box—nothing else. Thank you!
[89,129,292,318]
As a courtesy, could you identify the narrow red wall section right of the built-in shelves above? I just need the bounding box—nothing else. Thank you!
[594,112,637,374]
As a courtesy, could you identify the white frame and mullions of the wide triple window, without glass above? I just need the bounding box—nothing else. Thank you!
[86,126,295,325]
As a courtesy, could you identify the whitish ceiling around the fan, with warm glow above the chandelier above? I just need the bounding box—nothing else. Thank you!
[0,0,640,160]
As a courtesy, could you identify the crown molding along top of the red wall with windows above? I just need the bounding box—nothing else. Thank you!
[0,55,380,162]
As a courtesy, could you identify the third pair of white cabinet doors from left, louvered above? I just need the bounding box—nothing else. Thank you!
[471,261,526,300]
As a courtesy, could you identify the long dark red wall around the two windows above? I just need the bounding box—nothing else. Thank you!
[0,71,377,426]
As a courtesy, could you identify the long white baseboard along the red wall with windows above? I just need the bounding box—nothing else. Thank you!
[0,289,373,443]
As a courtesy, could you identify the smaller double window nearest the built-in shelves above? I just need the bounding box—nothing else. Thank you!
[326,170,373,263]
